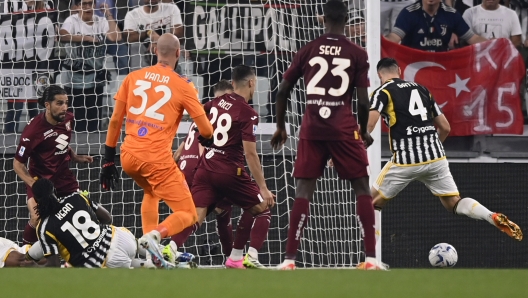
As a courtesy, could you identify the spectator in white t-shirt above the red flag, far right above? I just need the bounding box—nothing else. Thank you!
[463,0,522,47]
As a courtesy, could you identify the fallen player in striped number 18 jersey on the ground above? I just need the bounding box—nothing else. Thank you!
[28,178,175,268]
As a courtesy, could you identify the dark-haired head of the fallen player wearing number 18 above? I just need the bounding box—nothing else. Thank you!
[31,178,61,219]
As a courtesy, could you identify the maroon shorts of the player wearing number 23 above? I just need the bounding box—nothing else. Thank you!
[293,139,369,180]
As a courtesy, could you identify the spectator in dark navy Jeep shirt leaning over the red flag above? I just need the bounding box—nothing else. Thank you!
[387,0,487,52]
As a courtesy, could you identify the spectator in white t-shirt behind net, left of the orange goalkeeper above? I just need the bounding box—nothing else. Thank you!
[59,0,121,132]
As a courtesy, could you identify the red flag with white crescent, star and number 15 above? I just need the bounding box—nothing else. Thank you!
[381,38,526,136]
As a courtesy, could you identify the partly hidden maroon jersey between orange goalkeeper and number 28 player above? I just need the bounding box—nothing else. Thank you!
[178,122,200,186]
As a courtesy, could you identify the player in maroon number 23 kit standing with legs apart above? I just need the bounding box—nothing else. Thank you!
[271,0,385,270]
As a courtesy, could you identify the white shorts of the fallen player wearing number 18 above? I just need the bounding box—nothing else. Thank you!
[105,227,137,268]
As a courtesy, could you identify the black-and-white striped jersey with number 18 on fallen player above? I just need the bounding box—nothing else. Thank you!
[37,193,114,268]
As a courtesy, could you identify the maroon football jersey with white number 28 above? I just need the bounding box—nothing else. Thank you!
[199,93,258,175]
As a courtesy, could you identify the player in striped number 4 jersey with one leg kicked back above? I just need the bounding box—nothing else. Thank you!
[368,58,523,241]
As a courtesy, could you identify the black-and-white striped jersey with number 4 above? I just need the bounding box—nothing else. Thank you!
[370,79,445,165]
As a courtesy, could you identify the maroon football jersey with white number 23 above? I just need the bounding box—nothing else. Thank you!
[284,34,369,140]
